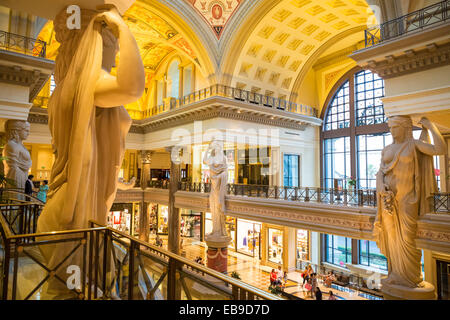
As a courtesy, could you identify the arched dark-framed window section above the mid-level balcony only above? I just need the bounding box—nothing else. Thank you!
[322,70,392,188]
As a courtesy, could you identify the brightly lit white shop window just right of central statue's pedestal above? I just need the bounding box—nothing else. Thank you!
[236,219,261,259]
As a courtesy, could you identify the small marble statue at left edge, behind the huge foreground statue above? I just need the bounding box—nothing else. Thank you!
[3,120,31,191]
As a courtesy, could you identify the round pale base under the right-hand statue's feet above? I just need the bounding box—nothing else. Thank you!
[381,279,437,300]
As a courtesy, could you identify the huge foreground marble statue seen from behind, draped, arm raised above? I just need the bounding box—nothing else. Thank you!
[37,8,145,298]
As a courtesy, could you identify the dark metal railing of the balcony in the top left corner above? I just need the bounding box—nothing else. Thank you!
[0,31,47,58]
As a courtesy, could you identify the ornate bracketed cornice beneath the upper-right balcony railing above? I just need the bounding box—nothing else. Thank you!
[367,43,450,79]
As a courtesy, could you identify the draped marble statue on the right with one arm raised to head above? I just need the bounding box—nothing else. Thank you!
[374,116,446,298]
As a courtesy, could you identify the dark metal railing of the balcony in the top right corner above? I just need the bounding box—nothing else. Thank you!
[365,0,450,48]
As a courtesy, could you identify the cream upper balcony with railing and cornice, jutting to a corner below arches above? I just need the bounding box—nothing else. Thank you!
[29,84,322,133]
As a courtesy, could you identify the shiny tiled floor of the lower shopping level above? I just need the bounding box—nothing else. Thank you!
[150,236,368,300]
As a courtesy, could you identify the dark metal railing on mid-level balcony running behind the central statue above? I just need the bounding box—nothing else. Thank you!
[174,182,377,207]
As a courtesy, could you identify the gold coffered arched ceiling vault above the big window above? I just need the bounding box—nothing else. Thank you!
[232,0,373,97]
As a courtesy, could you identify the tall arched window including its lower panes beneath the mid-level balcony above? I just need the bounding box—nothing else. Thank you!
[321,69,392,270]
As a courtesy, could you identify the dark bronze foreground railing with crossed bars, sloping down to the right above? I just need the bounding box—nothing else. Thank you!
[0,189,281,300]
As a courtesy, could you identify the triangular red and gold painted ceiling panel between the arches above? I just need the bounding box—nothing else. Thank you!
[188,0,243,39]
